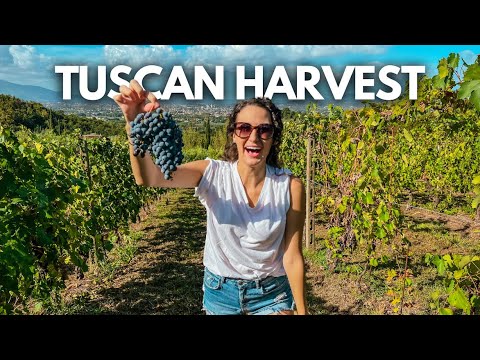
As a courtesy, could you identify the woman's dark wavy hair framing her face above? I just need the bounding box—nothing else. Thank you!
[222,97,283,168]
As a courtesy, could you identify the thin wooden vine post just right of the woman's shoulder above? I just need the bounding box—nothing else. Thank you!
[305,135,315,249]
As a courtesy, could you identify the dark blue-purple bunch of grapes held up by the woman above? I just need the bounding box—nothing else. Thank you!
[130,108,183,180]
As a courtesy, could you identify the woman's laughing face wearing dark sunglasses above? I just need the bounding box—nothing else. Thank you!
[233,105,274,166]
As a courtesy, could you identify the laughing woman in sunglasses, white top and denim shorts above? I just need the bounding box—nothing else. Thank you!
[114,80,307,315]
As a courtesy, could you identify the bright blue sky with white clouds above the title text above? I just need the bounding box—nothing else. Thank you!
[0,45,480,91]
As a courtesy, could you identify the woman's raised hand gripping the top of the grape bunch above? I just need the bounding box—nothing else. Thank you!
[113,80,160,126]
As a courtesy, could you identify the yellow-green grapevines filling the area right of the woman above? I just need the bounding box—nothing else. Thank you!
[283,54,480,314]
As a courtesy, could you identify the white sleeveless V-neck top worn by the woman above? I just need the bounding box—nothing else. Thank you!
[195,158,292,280]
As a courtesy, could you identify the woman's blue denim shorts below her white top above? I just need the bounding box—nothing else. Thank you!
[203,268,294,315]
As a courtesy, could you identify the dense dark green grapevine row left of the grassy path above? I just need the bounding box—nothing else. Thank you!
[0,127,162,313]
